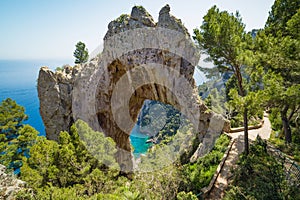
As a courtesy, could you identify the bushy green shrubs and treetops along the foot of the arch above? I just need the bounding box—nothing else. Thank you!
[16,120,229,200]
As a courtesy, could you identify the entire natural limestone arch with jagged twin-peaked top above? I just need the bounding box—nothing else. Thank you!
[38,5,228,172]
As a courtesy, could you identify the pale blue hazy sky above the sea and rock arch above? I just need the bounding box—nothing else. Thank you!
[0,0,274,61]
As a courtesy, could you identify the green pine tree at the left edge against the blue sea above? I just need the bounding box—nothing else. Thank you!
[0,98,38,170]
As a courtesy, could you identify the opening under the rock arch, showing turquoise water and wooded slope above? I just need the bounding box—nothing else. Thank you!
[130,99,190,158]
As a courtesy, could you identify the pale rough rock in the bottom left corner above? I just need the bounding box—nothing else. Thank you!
[0,165,25,200]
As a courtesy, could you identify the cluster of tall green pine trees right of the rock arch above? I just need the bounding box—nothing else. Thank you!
[198,0,300,150]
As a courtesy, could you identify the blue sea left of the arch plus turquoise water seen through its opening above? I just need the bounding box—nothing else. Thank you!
[0,60,149,157]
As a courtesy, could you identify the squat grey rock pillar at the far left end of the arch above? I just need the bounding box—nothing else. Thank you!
[38,65,80,140]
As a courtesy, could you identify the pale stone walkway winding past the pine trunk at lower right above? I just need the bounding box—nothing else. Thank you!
[205,114,271,200]
